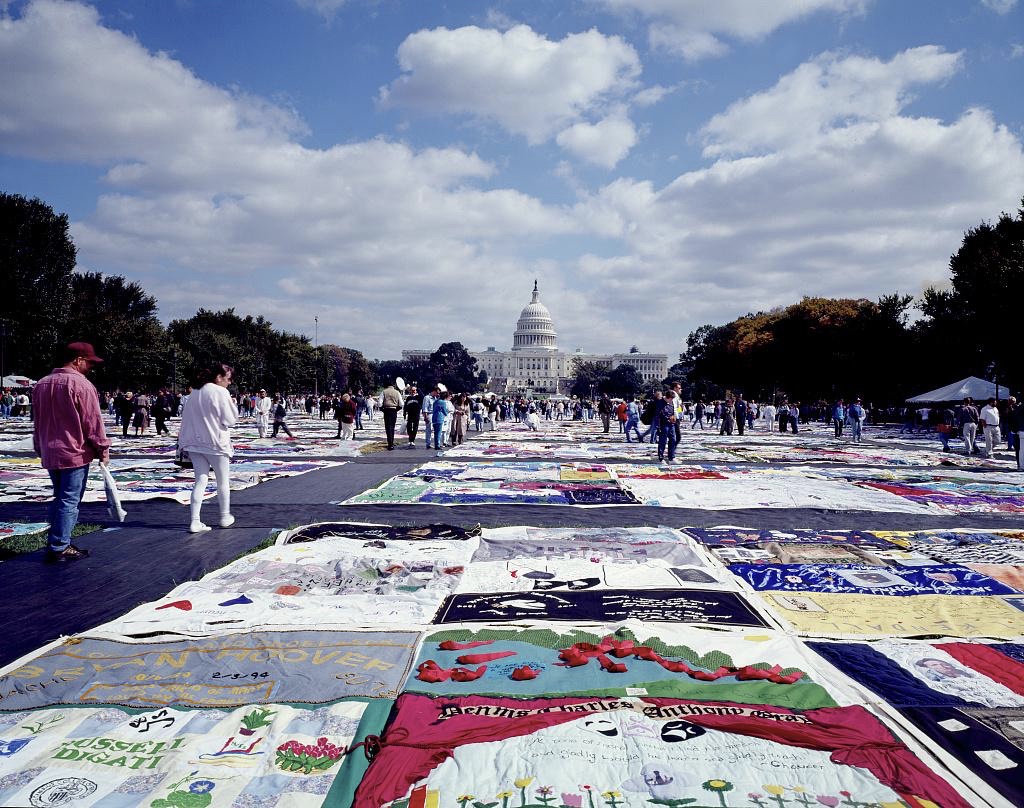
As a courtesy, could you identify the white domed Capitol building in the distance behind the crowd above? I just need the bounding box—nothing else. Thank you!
[401,281,669,395]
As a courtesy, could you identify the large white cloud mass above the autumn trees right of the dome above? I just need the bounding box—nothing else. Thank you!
[578,49,1024,345]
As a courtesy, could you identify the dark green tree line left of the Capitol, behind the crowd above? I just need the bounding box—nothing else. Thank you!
[0,194,486,393]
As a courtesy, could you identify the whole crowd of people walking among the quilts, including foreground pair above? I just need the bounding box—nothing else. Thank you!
[14,342,1024,561]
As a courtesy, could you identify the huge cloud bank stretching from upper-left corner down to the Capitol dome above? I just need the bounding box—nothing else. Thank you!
[0,1,579,355]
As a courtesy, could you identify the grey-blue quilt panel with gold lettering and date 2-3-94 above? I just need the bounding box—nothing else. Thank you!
[0,631,419,712]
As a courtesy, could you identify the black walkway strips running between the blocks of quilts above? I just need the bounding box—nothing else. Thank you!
[0,434,1019,666]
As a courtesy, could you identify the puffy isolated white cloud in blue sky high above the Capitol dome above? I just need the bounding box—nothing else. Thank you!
[380,25,641,144]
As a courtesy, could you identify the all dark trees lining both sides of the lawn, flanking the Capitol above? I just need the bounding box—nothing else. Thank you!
[0,194,1024,403]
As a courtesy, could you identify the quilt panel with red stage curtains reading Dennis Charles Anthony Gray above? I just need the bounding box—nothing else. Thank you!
[354,694,972,808]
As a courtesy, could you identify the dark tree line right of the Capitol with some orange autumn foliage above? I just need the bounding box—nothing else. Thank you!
[670,200,1024,405]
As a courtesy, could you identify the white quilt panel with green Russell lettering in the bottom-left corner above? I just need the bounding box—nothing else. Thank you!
[0,701,367,808]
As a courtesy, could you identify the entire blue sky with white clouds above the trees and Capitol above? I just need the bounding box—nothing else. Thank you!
[0,0,1024,359]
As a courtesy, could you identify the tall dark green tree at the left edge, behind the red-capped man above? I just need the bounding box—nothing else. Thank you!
[0,194,76,378]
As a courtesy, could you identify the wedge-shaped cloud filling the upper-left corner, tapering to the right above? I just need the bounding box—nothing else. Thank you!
[0,0,304,163]
